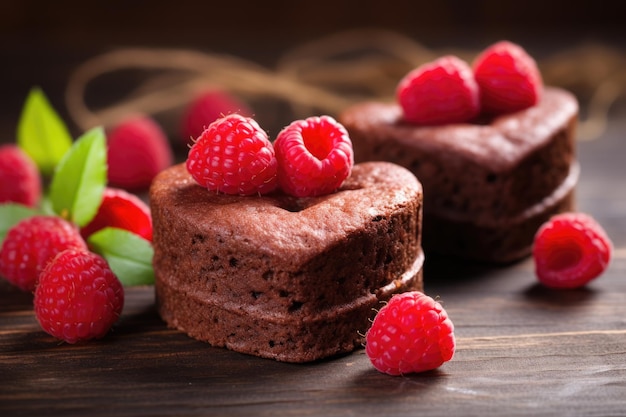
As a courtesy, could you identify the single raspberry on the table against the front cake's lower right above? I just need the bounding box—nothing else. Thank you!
[365,291,455,375]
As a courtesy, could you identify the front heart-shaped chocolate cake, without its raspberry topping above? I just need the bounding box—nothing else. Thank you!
[150,162,424,362]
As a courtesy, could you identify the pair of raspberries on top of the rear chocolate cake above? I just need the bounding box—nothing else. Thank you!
[396,41,543,125]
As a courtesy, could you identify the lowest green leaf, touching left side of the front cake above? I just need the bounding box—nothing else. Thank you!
[87,227,154,286]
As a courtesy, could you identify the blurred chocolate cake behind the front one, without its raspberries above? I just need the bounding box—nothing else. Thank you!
[338,87,579,263]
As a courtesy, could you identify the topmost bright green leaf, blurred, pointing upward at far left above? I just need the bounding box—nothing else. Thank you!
[17,87,72,176]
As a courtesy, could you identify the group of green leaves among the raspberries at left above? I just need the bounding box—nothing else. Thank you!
[0,88,154,286]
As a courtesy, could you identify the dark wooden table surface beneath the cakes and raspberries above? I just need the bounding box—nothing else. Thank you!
[0,78,626,417]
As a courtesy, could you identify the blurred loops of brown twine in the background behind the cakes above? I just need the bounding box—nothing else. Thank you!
[65,29,626,140]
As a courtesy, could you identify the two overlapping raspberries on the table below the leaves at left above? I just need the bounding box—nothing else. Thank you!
[0,215,124,343]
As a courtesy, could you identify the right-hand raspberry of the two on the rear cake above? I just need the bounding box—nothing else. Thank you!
[472,41,543,114]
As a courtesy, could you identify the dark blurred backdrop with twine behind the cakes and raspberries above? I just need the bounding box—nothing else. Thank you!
[0,0,626,245]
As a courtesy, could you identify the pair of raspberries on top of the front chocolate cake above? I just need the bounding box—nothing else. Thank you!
[186,113,354,197]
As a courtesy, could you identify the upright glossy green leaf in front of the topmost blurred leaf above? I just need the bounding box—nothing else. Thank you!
[49,127,107,227]
